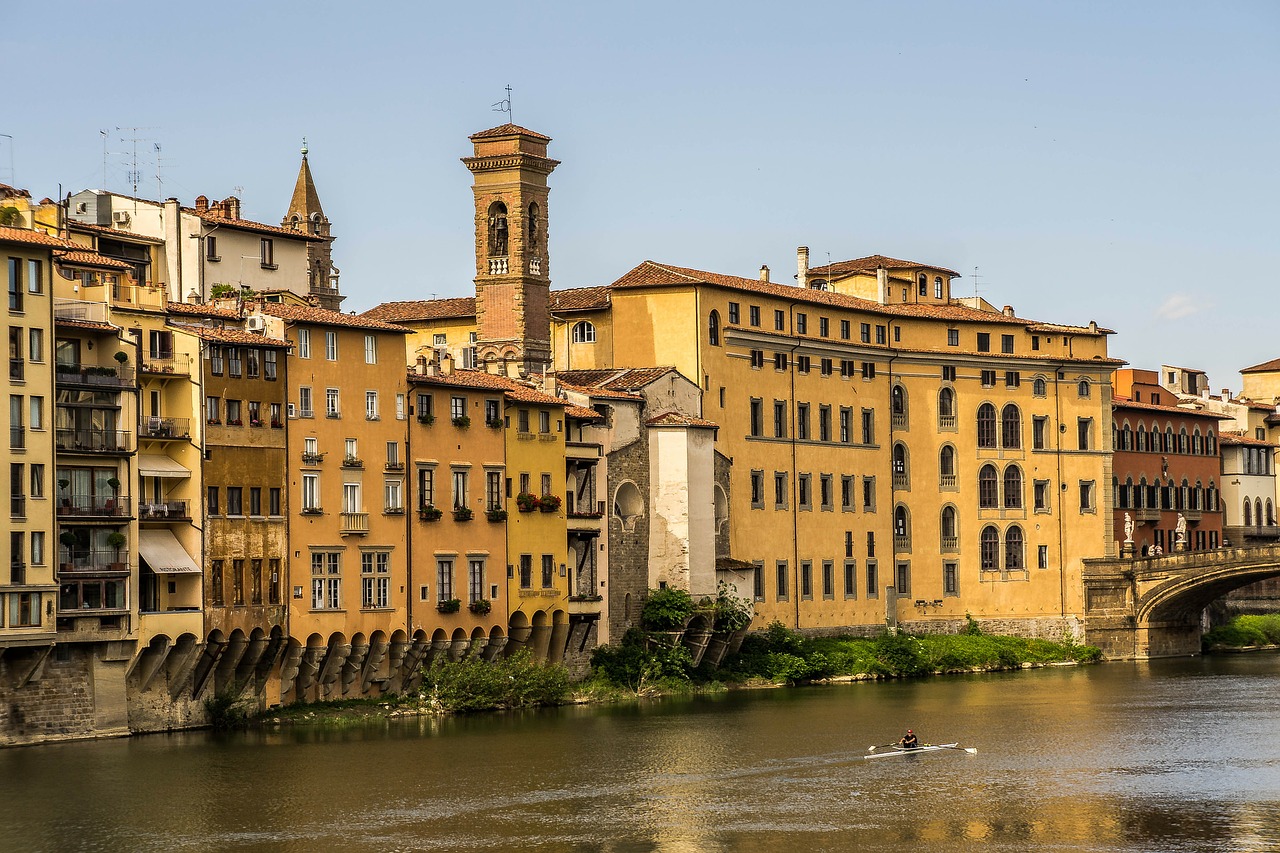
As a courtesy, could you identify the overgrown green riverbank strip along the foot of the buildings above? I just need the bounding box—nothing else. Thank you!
[247,624,1101,727]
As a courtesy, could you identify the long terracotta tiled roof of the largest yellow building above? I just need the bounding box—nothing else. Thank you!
[611,261,1064,325]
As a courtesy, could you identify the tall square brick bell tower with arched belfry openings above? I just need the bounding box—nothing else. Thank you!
[462,124,559,375]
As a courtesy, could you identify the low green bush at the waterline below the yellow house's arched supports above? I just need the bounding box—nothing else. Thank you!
[422,649,568,712]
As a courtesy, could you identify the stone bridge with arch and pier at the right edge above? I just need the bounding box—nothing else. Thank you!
[1083,546,1280,660]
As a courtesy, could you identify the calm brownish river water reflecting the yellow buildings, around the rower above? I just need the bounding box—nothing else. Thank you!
[0,654,1280,853]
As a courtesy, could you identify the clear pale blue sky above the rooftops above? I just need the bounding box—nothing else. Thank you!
[0,0,1280,391]
